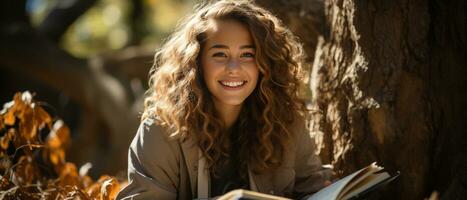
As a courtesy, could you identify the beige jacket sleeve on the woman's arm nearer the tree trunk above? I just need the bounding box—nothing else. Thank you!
[294,119,332,199]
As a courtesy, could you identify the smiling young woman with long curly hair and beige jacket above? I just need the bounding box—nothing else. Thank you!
[117,0,329,199]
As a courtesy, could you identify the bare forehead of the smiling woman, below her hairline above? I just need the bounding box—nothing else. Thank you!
[206,19,253,45]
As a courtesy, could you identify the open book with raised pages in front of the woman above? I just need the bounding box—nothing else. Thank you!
[217,163,399,200]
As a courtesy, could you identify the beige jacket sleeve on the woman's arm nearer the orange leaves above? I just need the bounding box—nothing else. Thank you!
[116,120,180,199]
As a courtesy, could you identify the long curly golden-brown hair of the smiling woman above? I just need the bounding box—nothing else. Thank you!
[142,0,307,173]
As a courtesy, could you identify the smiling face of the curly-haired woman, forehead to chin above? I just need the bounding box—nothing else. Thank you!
[201,20,259,108]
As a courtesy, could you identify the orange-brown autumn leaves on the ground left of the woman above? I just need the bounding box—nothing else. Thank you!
[0,92,125,200]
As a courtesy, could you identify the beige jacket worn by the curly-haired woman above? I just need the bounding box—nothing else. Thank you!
[117,120,330,199]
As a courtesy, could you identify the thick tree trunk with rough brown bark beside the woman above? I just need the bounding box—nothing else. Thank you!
[310,0,467,199]
